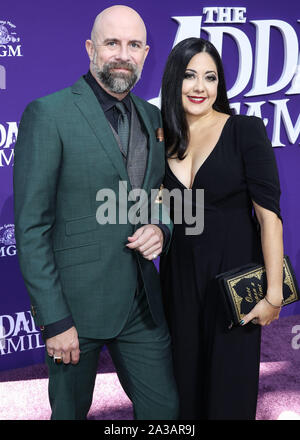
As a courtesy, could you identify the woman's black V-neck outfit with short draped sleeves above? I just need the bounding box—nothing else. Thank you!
[160,115,281,420]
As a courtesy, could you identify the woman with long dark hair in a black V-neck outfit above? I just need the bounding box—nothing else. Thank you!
[160,38,283,420]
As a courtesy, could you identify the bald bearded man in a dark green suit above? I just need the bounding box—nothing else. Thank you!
[14,6,178,420]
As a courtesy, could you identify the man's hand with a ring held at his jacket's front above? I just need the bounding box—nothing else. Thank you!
[126,225,164,260]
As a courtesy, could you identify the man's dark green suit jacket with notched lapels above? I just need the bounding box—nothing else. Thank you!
[14,78,171,339]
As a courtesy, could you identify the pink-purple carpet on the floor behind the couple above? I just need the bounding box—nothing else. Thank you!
[0,315,300,420]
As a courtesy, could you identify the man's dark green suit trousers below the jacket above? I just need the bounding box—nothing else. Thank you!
[46,291,179,420]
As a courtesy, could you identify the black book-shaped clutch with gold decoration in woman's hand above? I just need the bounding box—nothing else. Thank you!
[216,255,300,328]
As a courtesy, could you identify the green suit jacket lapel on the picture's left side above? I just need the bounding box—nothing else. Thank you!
[72,78,131,191]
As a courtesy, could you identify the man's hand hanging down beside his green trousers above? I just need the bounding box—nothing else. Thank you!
[46,327,80,364]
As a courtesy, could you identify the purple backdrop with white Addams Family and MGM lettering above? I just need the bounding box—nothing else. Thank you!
[0,0,300,370]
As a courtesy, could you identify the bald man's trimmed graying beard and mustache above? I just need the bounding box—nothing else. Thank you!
[96,63,141,94]
